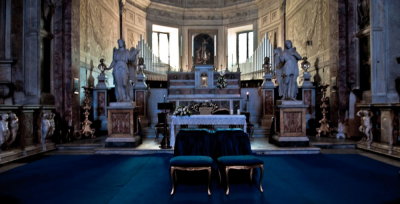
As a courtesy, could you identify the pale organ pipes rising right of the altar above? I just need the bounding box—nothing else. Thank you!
[239,34,274,80]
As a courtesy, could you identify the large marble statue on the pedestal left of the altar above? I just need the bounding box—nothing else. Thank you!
[108,39,140,102]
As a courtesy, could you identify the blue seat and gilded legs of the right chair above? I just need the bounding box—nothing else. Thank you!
[218,155,264,195]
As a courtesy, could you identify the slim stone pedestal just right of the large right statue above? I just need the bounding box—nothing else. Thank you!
[301,72,316,135]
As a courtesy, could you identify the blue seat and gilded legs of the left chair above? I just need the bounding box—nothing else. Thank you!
[170,155,213,195]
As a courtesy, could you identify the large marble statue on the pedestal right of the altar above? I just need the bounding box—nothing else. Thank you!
[275,40,302,100]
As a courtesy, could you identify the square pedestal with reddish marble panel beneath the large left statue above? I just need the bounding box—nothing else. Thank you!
[105,102,142,147]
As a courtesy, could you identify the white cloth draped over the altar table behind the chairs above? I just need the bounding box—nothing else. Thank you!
[170,115,247,147]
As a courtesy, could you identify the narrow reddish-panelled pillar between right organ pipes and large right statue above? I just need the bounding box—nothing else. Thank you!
[261,73,275,129]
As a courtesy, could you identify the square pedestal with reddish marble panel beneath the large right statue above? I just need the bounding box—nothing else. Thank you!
[272,100,309,146]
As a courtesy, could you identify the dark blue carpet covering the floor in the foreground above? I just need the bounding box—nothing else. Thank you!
[0,154,400,204]
